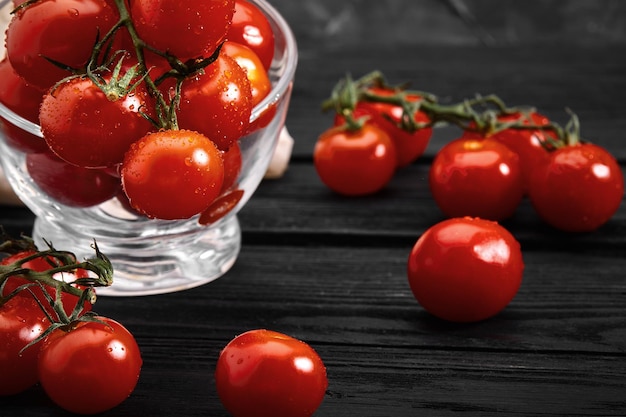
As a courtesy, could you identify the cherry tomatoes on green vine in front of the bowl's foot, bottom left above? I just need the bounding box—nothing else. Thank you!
[0,231,142,414]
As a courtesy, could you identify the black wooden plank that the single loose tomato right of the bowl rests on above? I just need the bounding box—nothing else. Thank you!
[90,244,626,358]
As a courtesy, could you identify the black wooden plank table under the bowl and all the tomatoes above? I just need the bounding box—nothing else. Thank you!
[0,4,626,417]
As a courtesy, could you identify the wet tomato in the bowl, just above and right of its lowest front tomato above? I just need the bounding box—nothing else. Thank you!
[161,54,253,150]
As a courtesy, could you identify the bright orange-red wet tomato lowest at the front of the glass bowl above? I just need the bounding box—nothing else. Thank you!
[121,130,224,220]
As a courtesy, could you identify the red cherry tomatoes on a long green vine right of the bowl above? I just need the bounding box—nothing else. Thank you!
[314,72,624,232]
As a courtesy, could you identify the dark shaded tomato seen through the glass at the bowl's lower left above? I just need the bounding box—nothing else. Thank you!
[26,152,122,207]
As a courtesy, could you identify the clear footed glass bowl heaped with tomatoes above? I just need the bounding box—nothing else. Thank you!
[0,0,298,296]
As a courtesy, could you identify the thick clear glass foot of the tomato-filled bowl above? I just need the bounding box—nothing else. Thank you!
[33,211,241,296]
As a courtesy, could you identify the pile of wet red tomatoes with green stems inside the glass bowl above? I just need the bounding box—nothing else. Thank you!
[0,0,275,224]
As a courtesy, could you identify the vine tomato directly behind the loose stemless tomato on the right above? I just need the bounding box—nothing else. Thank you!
[429,138,524,221]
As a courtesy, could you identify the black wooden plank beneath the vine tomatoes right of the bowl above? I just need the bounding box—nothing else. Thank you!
[240,163,626,247]
